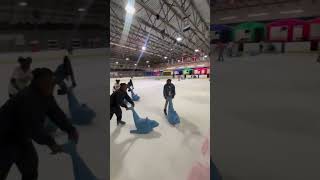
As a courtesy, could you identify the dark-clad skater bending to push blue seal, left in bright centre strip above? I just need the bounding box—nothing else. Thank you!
[110,83,134,125]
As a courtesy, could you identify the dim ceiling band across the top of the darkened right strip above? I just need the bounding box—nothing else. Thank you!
[211,0,320,24]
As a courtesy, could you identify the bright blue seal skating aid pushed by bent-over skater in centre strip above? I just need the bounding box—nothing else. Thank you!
[130,108,159,134]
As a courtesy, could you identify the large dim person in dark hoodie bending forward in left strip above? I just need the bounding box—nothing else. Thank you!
[0,68,78,180]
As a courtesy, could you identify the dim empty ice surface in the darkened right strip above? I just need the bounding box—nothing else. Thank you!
[211,54,320,180]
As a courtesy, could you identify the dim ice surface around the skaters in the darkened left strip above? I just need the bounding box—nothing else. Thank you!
[0,55,109,180]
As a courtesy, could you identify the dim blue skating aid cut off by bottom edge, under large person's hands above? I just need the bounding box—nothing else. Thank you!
[63,142,98,180]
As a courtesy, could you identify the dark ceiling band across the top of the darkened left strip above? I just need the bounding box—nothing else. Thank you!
[0,0,109,25]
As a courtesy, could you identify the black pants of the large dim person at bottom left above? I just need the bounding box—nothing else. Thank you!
[0,141,39,180]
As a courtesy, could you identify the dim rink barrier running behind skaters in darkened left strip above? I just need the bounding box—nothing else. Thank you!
[0,48,108,64]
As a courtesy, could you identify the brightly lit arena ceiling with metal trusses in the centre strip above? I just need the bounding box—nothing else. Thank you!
[110,0,210,68]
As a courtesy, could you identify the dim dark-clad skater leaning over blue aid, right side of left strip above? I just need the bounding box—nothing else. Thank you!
[54,56,77,95]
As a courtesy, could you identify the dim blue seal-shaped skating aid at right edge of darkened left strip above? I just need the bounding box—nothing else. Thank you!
[67,90,96,125]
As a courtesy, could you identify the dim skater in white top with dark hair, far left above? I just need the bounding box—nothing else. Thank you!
[9,57,32,98]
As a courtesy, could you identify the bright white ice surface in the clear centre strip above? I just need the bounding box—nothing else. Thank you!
[110,77,210,180]
